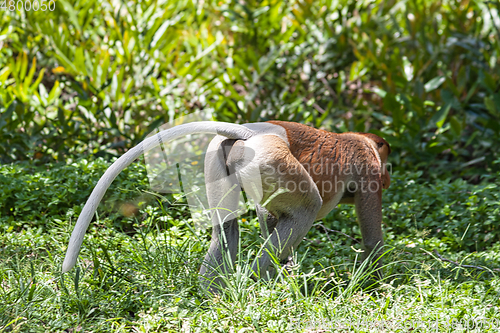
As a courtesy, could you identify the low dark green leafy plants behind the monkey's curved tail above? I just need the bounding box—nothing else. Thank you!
[0,159,149,230]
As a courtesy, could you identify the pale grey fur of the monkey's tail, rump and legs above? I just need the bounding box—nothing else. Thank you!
[63,122,383,292]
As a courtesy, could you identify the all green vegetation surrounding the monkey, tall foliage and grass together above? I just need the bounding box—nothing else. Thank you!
[0,0,500,332]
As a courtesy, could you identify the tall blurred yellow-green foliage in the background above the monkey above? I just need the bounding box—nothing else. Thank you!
[0,0,500,176]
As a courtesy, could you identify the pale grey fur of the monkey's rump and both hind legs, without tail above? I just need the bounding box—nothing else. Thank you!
[200,134,322,291]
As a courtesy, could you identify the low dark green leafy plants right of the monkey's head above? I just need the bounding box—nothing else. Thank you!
[384,172,500,251]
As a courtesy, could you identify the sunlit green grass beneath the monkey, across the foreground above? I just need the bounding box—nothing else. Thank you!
[0,160,500,332]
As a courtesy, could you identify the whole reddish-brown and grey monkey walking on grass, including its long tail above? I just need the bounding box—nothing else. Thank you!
[62,121,391,292]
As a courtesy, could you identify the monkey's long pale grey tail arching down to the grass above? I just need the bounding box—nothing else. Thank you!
[62,121,255,273]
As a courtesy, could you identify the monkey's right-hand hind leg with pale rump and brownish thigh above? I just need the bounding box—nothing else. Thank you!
[236,135,322,277]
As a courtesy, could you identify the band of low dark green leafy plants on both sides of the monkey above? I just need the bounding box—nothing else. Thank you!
[0,158,500,251]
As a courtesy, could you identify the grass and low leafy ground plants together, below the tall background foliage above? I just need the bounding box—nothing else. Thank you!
[0,159,500,332]
